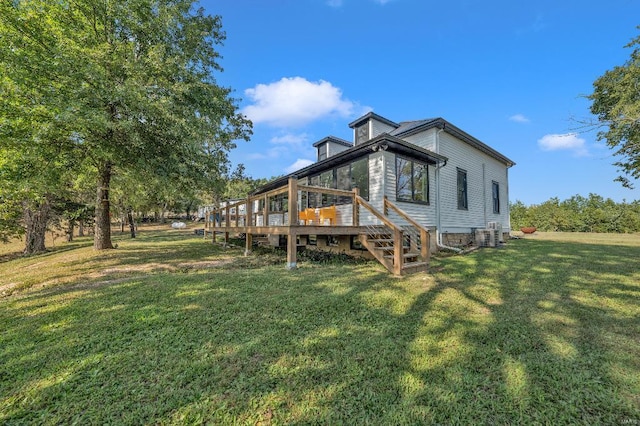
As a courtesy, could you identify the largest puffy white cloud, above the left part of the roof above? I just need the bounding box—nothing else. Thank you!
[242,77,356,127]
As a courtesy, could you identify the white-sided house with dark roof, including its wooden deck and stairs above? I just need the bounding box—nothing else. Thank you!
[210,112,515,275]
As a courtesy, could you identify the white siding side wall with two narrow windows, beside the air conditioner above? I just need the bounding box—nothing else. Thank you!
[439,132,509,233]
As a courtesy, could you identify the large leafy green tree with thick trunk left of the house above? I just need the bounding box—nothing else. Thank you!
[0,0,251,249]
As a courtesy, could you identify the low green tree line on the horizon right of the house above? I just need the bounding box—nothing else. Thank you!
[510,194,640,233]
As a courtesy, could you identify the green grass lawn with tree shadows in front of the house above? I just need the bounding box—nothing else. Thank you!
[0,228,640,425]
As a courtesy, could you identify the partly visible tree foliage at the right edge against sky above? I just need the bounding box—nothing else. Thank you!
[588,27,640,188]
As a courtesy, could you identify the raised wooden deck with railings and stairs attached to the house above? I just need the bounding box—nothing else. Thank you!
[205,178,430,275]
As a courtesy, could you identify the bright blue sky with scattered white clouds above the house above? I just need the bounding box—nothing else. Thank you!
[201,0,640,204]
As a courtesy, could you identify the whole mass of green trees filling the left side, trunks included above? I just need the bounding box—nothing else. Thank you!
[0,0,252,254]
